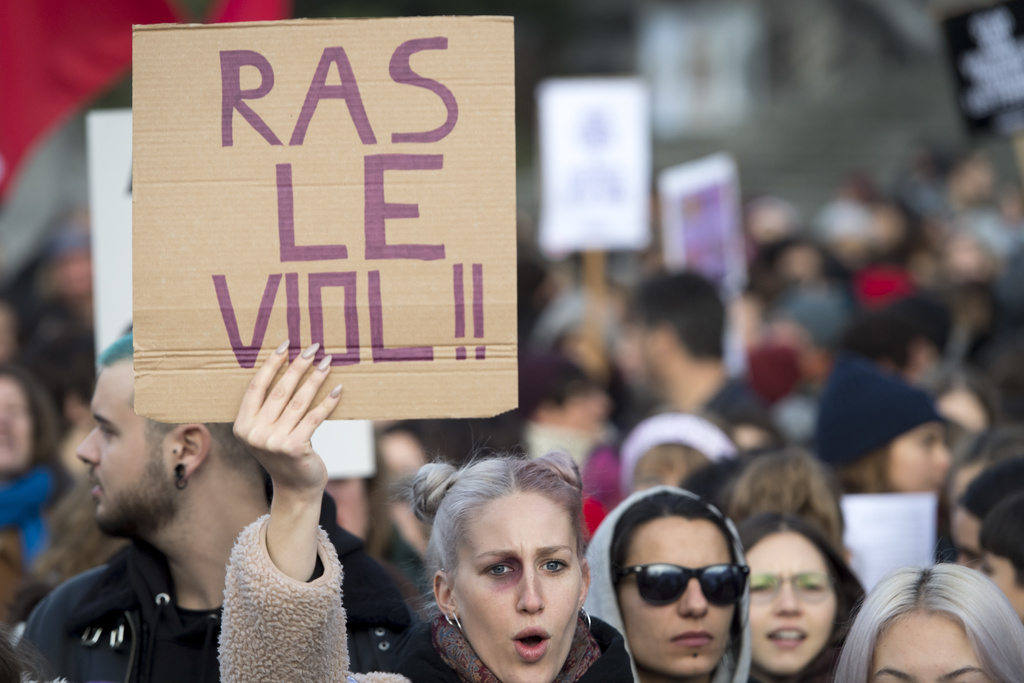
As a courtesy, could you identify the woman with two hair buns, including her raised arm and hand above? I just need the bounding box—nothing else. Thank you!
[219,345,631,683]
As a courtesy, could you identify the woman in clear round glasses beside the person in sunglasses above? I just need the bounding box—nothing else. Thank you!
[739,512,864,683]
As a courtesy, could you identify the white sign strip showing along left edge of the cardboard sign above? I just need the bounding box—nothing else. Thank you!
[85,110,131,354]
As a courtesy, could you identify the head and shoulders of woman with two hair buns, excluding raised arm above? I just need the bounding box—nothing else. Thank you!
[398,454,631,683]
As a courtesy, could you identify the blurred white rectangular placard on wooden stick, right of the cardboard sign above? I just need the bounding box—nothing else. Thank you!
[537,78,651,258]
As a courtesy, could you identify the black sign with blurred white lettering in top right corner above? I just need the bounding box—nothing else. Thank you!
[942,0,1024,135]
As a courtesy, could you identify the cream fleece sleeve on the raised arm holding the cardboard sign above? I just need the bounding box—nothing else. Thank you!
[219,515,409,683]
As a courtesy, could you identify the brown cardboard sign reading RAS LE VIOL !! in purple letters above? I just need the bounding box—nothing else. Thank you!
[133,16,516,422]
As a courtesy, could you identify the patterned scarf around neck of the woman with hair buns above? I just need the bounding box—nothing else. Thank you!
[430,614,601,683]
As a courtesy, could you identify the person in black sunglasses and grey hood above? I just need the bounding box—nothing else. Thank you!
[586,486,751,683]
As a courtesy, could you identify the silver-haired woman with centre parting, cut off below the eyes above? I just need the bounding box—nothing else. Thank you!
[836,564,1024,683]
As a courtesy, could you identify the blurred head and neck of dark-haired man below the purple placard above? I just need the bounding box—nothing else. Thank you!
[632,272,763,420]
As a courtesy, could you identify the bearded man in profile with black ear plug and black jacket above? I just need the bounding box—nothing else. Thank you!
[26,335,410,683]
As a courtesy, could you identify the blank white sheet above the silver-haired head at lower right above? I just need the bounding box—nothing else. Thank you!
[842,494,938,591]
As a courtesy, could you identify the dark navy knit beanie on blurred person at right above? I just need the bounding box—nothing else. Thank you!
[815,354,943,466]
